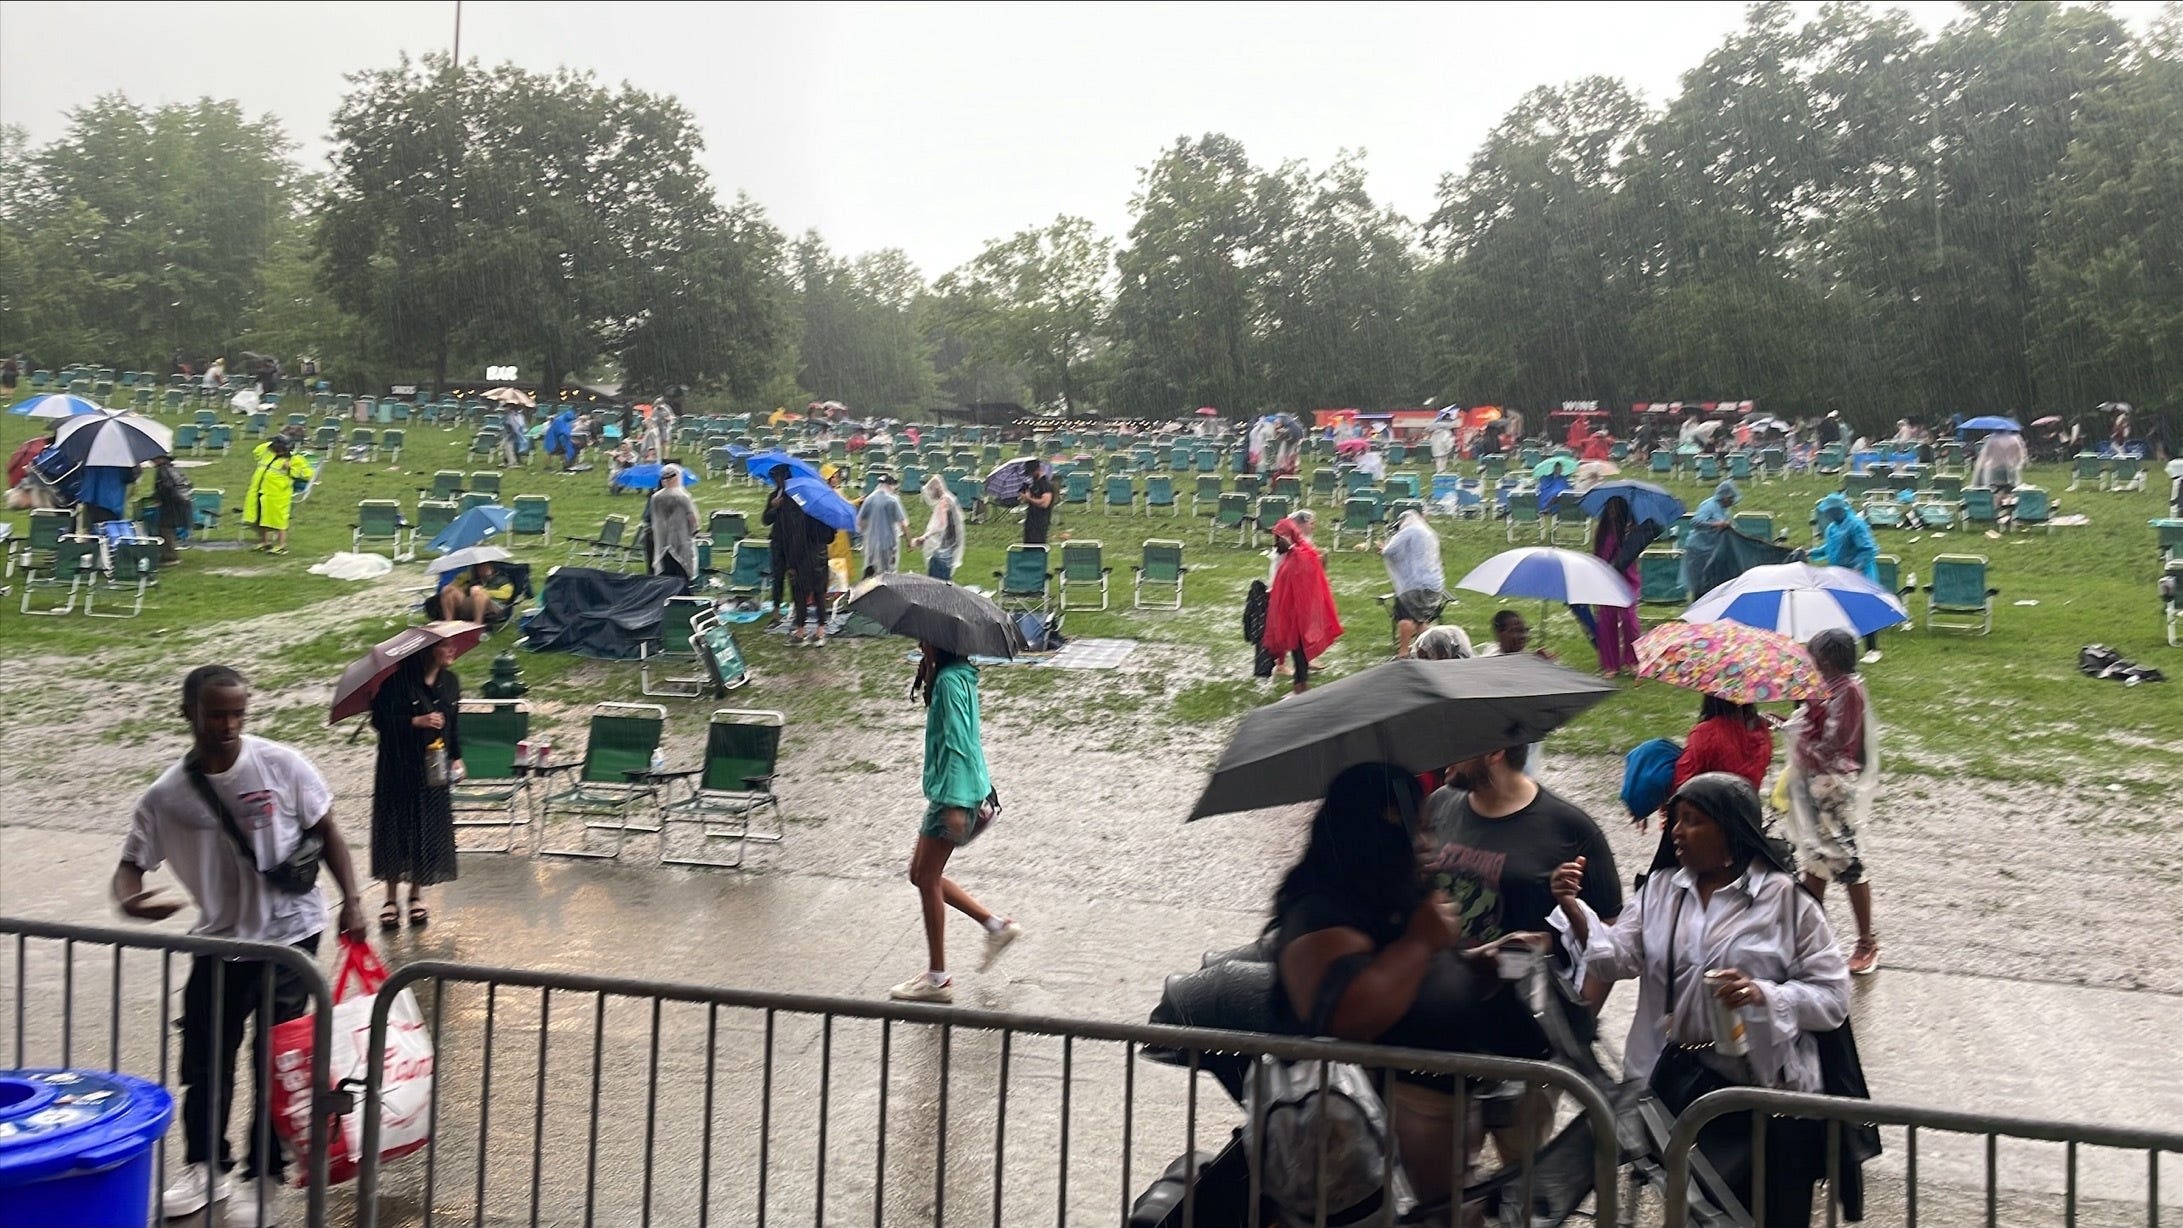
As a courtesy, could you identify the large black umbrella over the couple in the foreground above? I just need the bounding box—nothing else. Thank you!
[1190,654,1615,818]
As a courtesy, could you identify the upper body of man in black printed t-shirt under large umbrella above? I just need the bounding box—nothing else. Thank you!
[1425,746,1622,947]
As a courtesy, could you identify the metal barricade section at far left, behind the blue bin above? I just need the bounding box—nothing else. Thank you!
[0,916,334,1228]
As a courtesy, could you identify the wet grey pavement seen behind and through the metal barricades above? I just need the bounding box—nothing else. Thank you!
[0,816,2183,1224]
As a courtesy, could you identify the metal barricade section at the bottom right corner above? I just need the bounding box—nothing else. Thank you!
[1666,1086,2183,1228]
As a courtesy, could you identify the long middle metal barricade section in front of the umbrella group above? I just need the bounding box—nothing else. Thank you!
[358,962,1618,1228]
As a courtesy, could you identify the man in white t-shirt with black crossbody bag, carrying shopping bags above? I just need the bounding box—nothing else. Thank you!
[114,665,365,1224]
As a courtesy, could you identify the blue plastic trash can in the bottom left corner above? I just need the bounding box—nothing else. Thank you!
[0,1071,175,1228]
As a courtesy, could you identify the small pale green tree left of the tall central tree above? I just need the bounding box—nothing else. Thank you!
[934,214,1113,408]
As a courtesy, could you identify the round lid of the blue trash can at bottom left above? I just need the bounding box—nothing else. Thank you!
[0,1071,175,1189]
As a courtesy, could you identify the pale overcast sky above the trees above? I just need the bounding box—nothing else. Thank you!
[0,0,2155,277]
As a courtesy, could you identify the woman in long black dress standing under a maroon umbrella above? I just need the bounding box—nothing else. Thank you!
[371,641,463,929]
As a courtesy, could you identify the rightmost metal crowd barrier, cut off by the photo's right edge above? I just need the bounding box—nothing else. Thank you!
[1663,1086,2183,1228]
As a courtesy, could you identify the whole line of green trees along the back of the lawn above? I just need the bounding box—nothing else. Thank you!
[0,2,2183,423]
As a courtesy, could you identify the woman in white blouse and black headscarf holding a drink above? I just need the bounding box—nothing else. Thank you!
[1552,772,1849,1224]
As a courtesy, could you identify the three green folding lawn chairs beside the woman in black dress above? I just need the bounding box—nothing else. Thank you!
[452,700,788,868]
